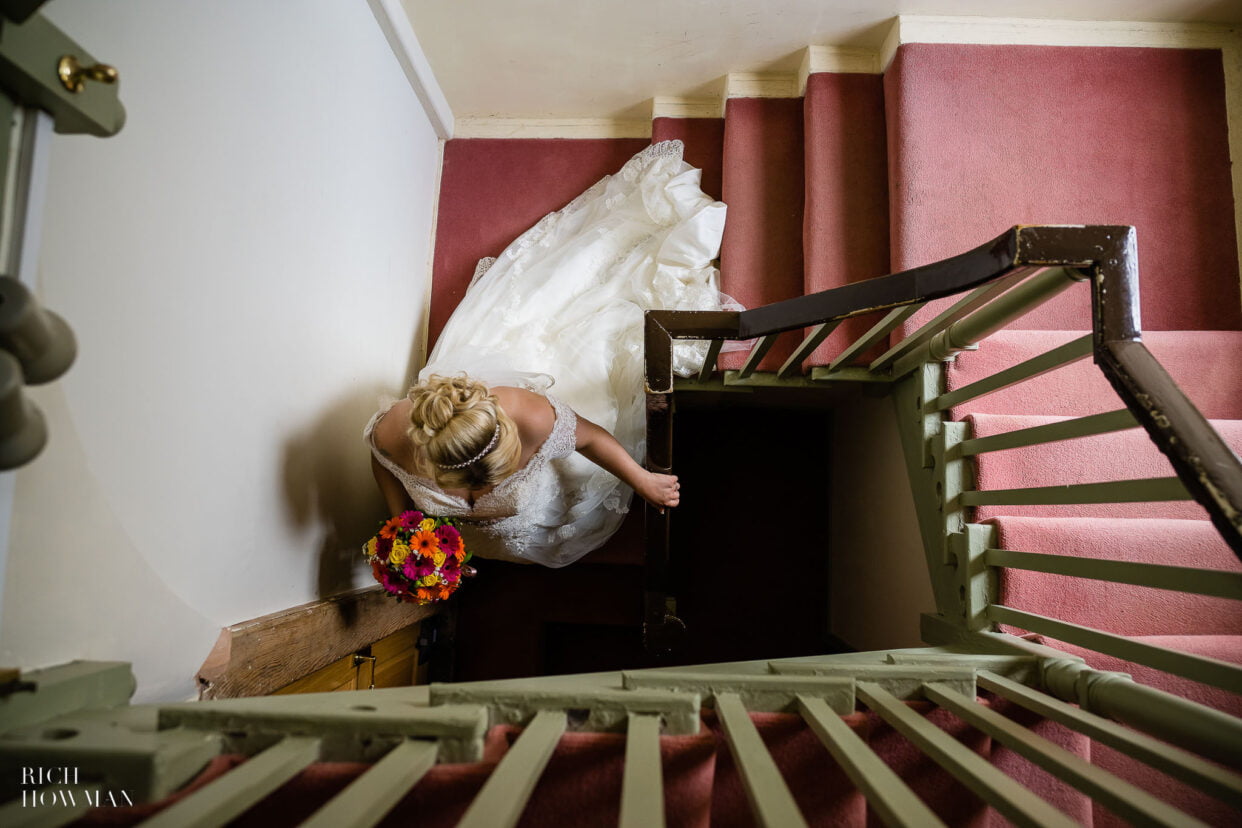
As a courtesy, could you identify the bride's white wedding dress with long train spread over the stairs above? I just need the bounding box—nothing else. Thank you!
[364,140,738,567]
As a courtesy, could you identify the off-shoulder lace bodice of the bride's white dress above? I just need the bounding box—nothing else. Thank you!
[363,395,578,562]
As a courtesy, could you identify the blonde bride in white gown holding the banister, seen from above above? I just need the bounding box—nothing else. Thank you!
[363,140,737,567]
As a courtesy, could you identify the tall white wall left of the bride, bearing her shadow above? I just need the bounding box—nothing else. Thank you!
[0,0,438,701]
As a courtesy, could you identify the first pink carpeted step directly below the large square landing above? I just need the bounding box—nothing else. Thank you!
[945,330,1242,420]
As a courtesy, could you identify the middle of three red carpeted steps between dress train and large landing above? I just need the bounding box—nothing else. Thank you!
[719,98,805,371]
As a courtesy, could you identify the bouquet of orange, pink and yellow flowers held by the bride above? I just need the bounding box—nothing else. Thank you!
[363,510,474,606]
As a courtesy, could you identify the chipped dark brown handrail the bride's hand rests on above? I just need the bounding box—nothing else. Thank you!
[646,225,1242,645]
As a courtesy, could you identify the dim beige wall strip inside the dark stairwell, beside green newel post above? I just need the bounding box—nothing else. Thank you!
[828,395,935,650]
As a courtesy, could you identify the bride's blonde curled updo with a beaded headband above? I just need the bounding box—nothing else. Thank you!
[406,374,522,489]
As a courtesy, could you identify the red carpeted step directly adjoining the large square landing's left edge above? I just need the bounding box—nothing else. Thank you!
[802,72,888,367]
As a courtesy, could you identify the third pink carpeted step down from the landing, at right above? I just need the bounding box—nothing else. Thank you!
[987,518,1242,636]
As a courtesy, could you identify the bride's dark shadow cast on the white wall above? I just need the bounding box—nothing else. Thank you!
[283,386,397,608]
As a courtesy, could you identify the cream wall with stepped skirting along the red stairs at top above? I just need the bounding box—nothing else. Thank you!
[401,0,1242,118]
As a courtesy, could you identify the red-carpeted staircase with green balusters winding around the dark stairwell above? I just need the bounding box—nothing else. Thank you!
[0,45,1242,826]
